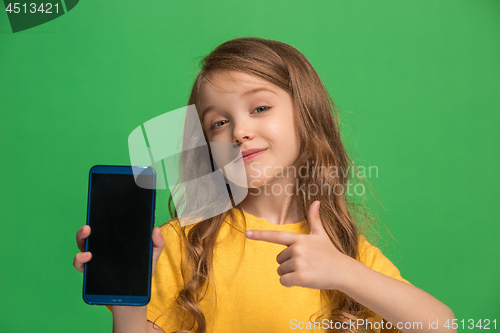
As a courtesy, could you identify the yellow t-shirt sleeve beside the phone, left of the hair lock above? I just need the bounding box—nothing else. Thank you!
[106,220,184,332]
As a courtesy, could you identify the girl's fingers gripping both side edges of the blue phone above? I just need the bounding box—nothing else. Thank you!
[73,225,165,274]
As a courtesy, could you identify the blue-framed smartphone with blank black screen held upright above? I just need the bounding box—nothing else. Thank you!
[83,165,156,306]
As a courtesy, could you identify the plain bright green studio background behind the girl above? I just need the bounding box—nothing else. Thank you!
[0,0,500,333]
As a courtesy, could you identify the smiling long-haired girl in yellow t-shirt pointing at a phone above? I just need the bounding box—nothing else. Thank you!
[74,38,454,333]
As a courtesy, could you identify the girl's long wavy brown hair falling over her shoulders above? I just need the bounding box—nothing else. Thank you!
[160,37,382,333]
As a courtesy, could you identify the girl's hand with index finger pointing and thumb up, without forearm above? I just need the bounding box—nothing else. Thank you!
[246,201,354,289]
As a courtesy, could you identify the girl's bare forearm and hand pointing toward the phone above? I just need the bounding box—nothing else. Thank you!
[247,201,456,333]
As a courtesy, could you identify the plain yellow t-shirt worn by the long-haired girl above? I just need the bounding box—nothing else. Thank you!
[107,209,409,333]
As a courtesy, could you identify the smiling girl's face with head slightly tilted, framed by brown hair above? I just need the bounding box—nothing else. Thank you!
[200,71,300,191]
